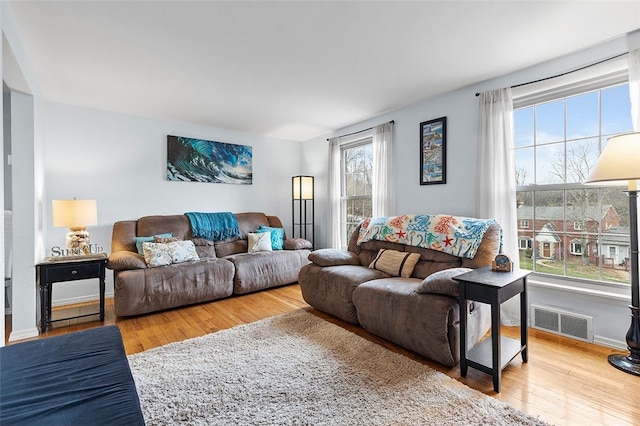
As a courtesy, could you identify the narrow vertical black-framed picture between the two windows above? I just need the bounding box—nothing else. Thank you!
[420,117,447,185]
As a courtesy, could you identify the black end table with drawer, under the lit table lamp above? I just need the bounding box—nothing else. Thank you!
[36,254,107,333]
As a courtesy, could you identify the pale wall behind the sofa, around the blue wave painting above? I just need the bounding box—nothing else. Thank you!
[44,102,301,305]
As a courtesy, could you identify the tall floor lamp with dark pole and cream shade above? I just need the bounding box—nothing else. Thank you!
[585,132,640,376]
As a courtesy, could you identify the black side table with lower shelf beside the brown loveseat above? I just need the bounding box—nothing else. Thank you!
[454,266,531,392]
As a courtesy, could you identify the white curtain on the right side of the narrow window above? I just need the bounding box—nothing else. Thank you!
[372,122,395,217]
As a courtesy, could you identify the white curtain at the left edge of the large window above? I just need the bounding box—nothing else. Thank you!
[476,88,520,325]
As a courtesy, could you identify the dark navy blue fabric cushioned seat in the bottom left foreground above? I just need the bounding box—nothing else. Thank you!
[0,325,144,426]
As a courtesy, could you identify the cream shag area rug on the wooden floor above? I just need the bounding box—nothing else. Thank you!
[129,311,545,426]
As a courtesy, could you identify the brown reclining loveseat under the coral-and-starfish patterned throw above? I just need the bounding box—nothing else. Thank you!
[298,220,501,366]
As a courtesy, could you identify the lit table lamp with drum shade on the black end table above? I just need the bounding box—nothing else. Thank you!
[52,199,98,254]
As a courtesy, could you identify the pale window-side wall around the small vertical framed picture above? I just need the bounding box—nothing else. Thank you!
[302,31,640,347]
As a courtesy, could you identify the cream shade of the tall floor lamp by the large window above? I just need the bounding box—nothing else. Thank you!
[585,132,640,189]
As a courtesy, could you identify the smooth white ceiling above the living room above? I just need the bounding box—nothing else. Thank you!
[5,0,640,140]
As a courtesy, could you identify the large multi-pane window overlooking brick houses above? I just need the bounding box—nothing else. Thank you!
[514,65,633,285]
